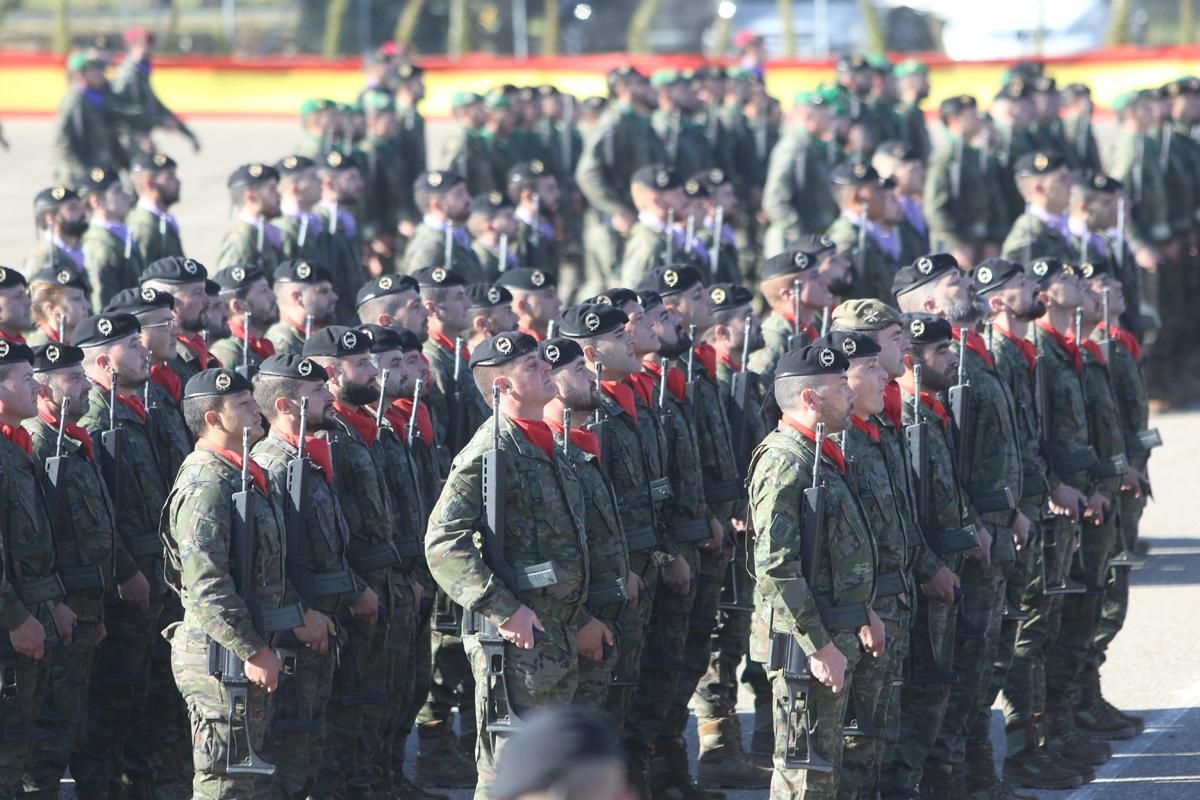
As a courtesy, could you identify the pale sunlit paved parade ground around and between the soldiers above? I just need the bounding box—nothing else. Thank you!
[0,120,1200,800]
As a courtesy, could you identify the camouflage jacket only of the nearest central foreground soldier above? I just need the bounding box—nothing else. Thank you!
[425,419,589,626]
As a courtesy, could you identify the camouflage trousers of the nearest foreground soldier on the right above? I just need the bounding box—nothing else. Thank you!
[769,632,862,800]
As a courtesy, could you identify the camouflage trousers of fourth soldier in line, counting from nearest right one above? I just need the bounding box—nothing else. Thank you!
[929,556,1013,765]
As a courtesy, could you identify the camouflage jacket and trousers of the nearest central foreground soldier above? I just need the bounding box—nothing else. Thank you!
[425,420,589,800]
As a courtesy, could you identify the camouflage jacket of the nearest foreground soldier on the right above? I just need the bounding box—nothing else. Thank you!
[750,422,878,661]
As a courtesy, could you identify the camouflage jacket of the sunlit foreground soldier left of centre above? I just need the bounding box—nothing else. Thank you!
[161,447,300,660]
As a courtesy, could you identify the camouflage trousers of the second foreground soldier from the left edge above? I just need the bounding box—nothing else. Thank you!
[25,621,100,800]
